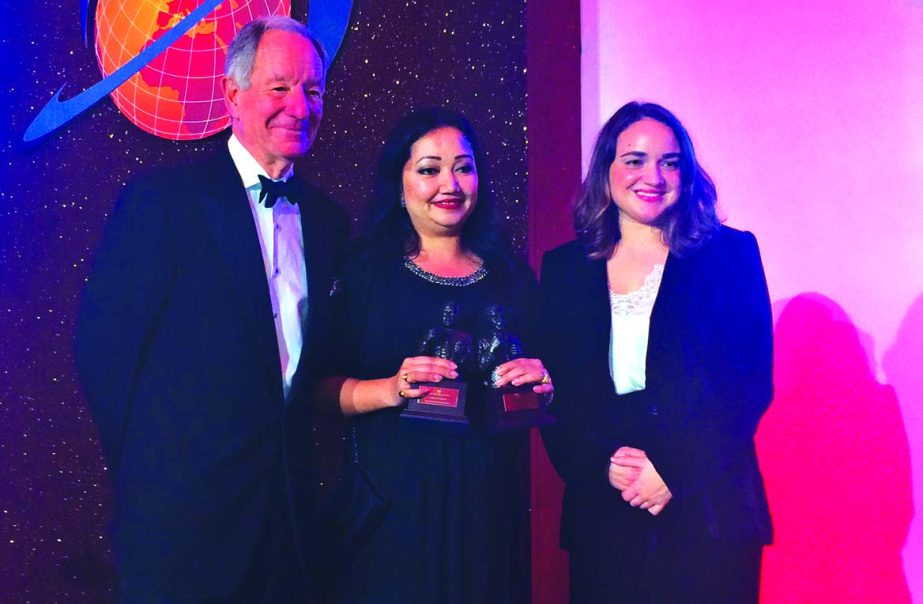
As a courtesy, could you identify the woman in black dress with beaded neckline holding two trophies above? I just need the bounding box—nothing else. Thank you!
[328,109,552,604]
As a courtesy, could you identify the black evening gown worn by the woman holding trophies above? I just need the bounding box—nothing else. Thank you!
[338,245,535,604]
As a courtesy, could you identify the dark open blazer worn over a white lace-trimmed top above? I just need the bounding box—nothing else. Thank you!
[541,227,772,544]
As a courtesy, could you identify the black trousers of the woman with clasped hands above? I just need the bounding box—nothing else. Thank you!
[569,519,763,604]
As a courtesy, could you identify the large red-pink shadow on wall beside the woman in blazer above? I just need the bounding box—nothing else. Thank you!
[757,293,913,604]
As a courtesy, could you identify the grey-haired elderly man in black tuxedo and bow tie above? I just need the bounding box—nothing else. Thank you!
[76,17,348,603]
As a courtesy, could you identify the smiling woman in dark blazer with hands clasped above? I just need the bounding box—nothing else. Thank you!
[541,103,772,604]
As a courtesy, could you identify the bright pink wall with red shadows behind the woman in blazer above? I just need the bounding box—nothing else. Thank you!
[581,0,923,602]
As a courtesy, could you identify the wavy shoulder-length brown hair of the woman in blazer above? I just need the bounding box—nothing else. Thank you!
[574,101,721,260]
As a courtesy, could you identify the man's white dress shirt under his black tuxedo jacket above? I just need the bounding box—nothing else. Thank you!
[228,135,308,399]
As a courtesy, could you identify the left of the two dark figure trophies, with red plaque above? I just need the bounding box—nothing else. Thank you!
[401,302,474,426]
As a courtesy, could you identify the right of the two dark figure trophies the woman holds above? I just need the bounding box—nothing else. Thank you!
[478,306,553,432]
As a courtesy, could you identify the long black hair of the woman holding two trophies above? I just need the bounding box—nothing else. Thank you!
[368,107,510,262]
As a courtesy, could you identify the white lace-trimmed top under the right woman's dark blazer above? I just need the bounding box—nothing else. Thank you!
[609,264,664,394]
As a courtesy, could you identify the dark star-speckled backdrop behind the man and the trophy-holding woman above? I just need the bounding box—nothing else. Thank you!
[0,0,527,604]
